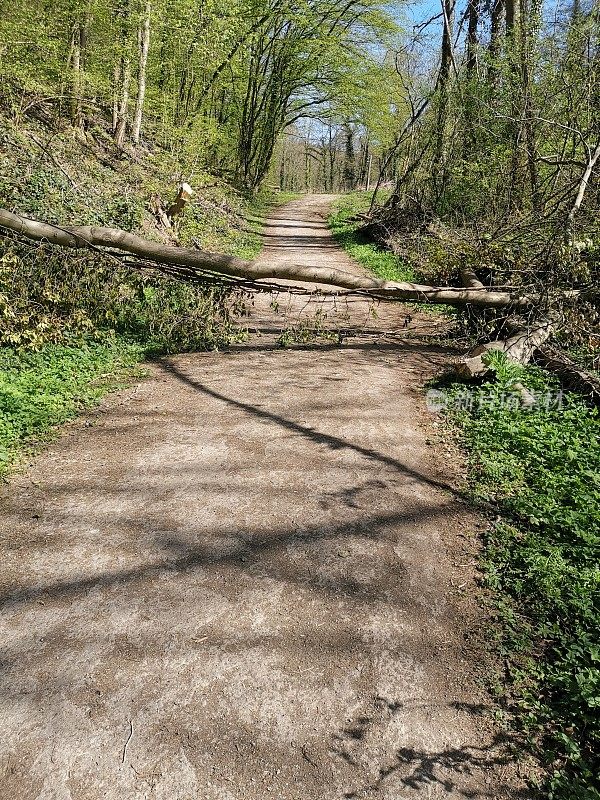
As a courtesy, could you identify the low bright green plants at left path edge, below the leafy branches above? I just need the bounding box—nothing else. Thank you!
[0,337,145,476]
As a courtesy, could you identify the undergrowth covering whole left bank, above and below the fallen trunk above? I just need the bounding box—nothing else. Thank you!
[0,112,288,473]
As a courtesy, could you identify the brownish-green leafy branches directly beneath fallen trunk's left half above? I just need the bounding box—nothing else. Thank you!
[0,238,246,352]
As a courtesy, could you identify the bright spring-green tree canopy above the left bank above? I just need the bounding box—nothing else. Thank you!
[0,0,399,193]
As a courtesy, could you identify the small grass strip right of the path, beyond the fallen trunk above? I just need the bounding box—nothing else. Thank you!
[329,192,415,281]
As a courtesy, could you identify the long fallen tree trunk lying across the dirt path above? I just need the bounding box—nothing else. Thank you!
[0,209,535,308]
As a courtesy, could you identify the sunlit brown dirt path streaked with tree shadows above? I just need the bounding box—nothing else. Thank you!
[0,199,519,800]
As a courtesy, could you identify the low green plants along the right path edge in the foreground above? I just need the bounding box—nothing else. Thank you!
[440,356,600,800]
